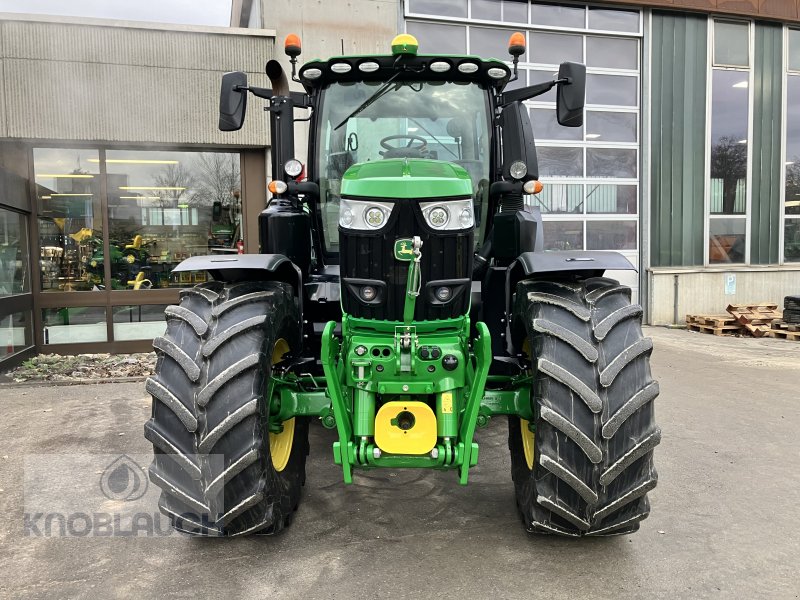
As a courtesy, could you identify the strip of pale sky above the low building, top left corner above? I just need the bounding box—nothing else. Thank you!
[0,0,231,27]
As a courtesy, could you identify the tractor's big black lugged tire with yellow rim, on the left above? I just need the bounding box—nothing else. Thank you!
[145,282,308,536]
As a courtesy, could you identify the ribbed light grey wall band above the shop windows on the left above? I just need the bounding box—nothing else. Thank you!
[0,14,275,147]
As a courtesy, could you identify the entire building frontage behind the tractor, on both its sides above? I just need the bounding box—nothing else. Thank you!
[0,0,800,366]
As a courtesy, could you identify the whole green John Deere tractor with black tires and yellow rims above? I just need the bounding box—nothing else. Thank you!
[145,34,660,537]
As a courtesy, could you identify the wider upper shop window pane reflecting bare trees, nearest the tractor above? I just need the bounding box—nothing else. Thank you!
[105,150,243,290]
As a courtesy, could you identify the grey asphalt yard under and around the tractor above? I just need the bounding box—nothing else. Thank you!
[0,328,800,600]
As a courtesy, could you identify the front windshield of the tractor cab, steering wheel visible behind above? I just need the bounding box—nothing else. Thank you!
[317,81,491,252]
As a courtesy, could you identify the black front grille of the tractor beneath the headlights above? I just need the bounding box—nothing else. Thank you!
[339,199,474,321]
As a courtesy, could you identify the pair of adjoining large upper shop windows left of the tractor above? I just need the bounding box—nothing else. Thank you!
[34,148,243,292]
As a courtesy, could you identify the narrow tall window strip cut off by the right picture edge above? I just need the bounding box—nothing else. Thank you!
[783,36,800,262]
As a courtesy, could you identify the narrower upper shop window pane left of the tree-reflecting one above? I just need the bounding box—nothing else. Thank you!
[33,148,105,292]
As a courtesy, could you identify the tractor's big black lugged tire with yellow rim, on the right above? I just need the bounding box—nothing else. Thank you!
[509,278,661,537]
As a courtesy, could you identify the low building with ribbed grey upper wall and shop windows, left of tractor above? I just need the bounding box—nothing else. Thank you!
[0,14,274,368]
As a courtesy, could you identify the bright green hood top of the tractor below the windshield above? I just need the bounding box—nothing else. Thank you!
[342,158,472,198]
